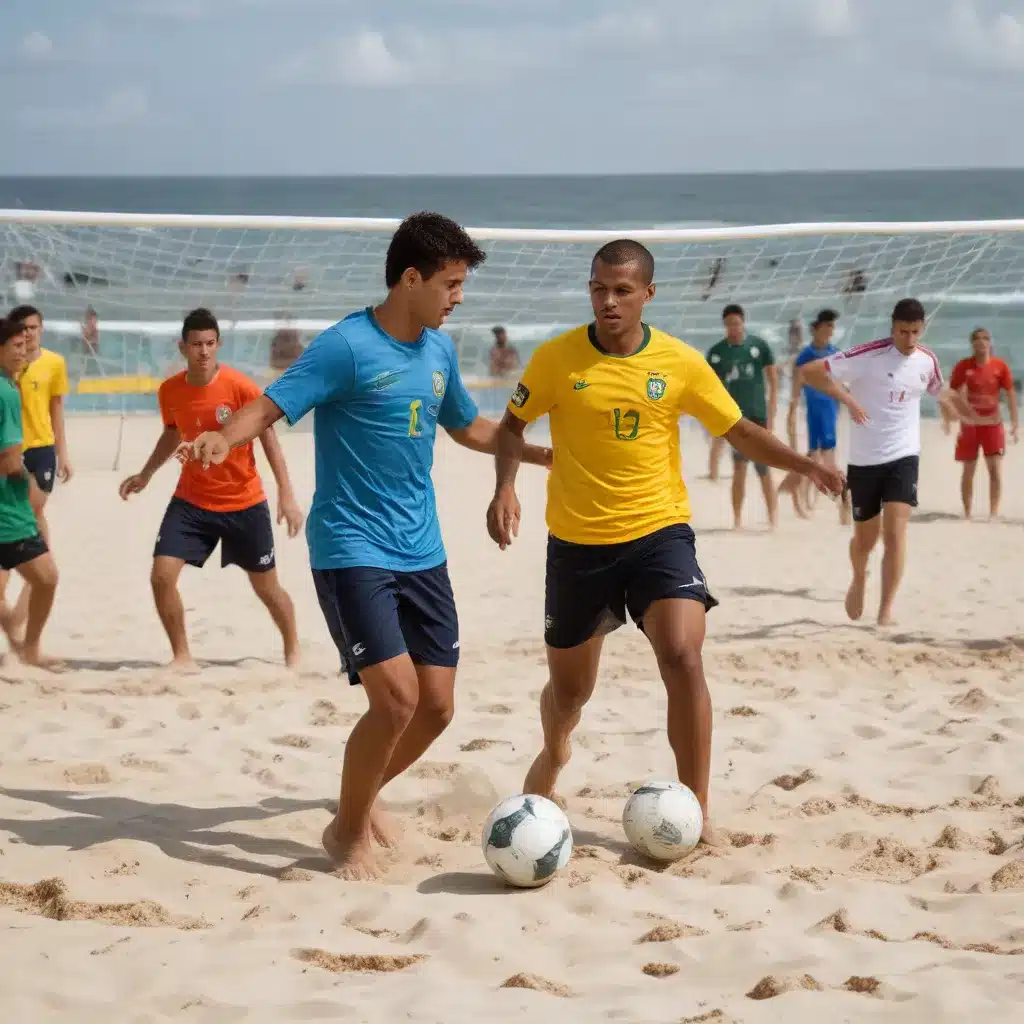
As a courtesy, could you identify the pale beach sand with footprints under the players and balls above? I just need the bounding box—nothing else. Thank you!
[0,418,1024,1024]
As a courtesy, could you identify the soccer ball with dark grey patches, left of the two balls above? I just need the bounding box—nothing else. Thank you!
[482,795,572,889]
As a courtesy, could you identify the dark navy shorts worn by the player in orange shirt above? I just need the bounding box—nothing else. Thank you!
[153,498,274,572]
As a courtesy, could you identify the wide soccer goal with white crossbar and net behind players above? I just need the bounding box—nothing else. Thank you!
[0,210,1024,468]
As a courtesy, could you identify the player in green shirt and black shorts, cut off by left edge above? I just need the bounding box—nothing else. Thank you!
[0,319,57,669]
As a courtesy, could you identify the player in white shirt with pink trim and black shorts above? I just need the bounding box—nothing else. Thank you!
[802,299,974,626]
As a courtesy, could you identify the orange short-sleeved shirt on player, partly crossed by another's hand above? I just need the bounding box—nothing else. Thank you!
[158,366,266,512]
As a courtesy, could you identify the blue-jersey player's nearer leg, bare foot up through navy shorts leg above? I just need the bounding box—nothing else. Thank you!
[313,567,420,879]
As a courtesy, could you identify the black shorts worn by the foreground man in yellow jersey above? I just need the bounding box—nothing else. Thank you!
[544,523,718,649]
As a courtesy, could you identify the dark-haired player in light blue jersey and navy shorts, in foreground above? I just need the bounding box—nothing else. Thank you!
[184,213,551,879]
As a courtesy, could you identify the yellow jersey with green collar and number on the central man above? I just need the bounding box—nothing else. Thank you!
[509,325,740,544]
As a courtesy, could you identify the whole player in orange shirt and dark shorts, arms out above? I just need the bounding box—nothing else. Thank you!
[119,309,302,672]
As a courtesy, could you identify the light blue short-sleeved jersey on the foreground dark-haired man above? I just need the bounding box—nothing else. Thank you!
[265,308,477,572]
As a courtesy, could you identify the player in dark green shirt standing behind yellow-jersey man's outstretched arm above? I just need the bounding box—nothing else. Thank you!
[708,304,778,529]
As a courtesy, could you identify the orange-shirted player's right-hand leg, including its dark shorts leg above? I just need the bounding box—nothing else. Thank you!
[219,501,299,669]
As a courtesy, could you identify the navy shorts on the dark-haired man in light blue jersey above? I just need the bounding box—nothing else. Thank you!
[312,562,459,686]
